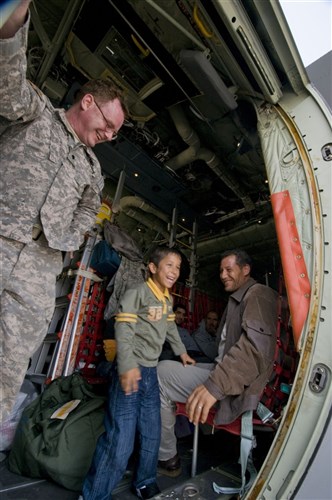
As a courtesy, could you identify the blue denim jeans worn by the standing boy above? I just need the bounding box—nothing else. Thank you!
[82,366,160,500]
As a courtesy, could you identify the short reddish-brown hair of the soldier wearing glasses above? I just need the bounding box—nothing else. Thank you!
[74,79,128,118]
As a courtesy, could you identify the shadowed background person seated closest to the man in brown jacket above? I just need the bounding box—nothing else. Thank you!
[191,310,219,363]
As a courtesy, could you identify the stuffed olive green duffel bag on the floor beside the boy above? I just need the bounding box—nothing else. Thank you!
[9,373,106,491]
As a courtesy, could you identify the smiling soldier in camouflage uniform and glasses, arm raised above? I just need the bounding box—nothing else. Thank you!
[0,0,126,420]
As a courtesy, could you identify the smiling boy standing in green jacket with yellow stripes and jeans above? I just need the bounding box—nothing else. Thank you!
[83,247,195,500]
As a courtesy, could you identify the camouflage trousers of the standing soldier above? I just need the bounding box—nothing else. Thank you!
[0,235,62,421]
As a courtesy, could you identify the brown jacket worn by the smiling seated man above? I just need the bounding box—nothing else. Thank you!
[204,278,278,424]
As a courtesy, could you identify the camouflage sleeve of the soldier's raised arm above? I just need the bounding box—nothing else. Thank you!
[0,13,47,122]
